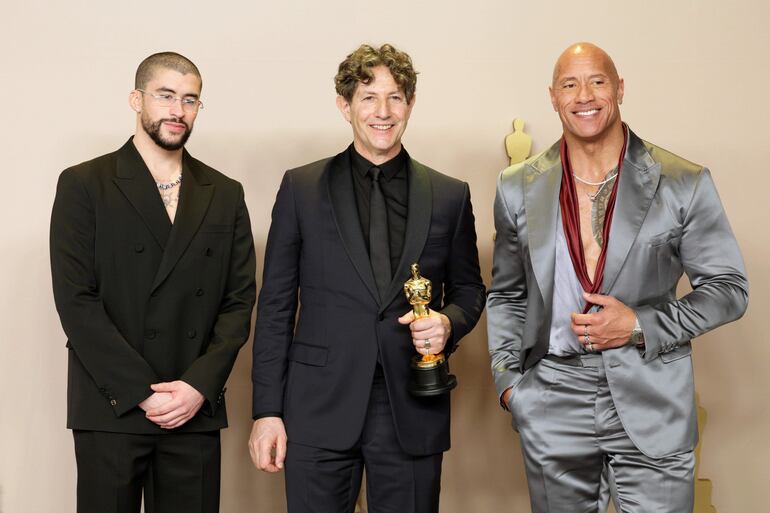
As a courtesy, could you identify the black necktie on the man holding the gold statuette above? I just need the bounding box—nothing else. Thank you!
[369,167,391,300]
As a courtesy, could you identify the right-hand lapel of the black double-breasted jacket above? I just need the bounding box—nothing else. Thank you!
[152,151,215,290]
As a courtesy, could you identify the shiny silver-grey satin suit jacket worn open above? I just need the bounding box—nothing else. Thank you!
[487,127,748,458]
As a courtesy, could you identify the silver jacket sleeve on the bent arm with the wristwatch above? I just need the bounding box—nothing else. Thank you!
[635,169,749,361]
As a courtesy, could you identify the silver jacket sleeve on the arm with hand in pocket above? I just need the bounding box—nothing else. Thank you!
[487,173,527,404]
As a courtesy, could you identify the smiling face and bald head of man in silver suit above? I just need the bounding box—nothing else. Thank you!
[549,43,623,142]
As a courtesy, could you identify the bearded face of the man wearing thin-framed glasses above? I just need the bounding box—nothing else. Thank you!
[131,68,201,151]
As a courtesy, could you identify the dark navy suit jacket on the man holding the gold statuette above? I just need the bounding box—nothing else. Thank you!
[252,152,484,455]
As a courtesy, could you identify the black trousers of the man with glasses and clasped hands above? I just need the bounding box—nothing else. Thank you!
[73,430,221,513]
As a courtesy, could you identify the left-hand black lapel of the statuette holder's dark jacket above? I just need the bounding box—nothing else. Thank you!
[326,151,380,304]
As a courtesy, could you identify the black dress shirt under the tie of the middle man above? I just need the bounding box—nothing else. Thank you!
[348,144,409,272]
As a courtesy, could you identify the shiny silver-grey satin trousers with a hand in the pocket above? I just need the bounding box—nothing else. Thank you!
[509,354,695,513]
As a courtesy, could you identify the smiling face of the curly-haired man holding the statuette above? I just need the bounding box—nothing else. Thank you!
[337,66,414,164]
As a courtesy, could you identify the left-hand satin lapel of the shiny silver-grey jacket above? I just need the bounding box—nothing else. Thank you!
[524,143,562,310]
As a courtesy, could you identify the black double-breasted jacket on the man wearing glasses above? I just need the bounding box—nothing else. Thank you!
[50,139,256,433]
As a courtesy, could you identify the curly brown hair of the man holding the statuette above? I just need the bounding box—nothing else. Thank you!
[334,43,417,103]
